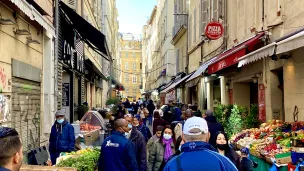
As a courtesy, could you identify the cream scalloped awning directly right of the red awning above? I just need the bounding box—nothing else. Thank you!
[238,42,276,67]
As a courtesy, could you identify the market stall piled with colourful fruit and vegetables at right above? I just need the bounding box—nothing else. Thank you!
[230,120,304,171]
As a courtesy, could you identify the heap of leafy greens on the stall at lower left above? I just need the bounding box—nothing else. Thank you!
[56,148,100,171]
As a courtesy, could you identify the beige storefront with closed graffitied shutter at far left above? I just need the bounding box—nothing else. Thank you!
[0,0,55,151]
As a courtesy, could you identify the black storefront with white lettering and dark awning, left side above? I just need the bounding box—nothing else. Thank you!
[58,2,108,121]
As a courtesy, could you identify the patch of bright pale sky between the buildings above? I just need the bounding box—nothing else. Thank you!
[116,0,157,34]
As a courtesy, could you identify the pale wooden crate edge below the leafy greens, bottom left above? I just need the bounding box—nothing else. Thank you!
[20,165,77,171]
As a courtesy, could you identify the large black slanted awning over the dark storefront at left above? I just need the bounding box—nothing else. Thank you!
[59,1,110,60]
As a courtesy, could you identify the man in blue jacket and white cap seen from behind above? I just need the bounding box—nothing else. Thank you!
[164,117,237,171]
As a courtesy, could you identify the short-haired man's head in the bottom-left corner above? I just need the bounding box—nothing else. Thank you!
[0,127,23,171]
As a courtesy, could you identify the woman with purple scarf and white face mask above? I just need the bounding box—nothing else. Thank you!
[148,125,175,171]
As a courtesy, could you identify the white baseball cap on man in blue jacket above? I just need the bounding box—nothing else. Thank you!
[183,117,208,135]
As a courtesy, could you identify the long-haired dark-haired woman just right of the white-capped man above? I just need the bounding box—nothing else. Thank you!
[215,131,240,170]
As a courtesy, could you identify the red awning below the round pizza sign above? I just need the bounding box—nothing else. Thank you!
[208,32,265,74]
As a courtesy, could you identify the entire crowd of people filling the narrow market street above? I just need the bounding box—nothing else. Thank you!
[0,99,254,171]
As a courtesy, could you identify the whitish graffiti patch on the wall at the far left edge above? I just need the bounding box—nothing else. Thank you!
[0,94,10,123]
